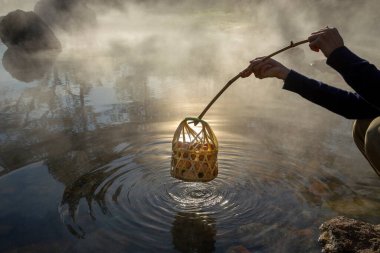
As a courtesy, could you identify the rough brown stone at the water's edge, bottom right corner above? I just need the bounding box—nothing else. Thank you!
[318,216,380,253]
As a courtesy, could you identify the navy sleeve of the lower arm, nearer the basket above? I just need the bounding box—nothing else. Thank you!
[283,70,380,119]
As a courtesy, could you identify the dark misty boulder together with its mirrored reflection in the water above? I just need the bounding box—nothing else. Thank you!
[0,10,61,82]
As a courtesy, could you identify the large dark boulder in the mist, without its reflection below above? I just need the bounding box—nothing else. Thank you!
[0,10,61,53]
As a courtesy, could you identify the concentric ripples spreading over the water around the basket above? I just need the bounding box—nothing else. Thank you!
[60,121,354,252]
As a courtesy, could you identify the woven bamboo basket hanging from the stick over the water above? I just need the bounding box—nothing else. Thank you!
[171,118,218,182]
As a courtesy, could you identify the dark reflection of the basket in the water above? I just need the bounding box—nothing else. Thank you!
[171,212,216,253]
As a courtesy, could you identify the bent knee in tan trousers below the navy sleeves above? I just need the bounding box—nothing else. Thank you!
[352,117,380,177]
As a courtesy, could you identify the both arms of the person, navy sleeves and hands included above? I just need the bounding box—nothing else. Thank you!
[241,27,380,119]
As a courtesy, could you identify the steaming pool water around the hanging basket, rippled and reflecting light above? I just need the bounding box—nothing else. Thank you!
[0,2,380,252]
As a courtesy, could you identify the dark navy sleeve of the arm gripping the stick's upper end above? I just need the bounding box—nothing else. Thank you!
[327,47,380,109]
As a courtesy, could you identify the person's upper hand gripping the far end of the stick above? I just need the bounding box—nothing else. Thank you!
[308,26,344,57]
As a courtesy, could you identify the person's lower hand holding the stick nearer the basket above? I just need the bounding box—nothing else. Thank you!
[240,57,290,80]
